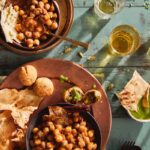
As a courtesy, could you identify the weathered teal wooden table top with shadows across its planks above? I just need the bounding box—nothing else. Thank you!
[0,0,150,150]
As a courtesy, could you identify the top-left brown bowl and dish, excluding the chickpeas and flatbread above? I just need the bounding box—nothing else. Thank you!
[0,0,74,55]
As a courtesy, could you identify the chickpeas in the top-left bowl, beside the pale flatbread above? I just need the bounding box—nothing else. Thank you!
[14,0,58,48]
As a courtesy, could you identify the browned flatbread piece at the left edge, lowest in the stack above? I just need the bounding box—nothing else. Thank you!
[0,111,17,150]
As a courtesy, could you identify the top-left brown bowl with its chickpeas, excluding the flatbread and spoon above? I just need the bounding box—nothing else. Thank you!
[0,0,73,55]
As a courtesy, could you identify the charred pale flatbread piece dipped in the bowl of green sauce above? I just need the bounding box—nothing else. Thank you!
[118,71,149,111]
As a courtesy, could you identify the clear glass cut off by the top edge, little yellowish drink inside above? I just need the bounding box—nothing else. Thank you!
[94,0,126,19]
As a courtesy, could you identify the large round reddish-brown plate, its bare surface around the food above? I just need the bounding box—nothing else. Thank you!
[0,59,112,150]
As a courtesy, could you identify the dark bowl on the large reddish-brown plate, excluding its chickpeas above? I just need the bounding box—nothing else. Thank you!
[26,103,101,150]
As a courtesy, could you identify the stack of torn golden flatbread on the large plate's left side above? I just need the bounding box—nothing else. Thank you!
[0,89,43,150]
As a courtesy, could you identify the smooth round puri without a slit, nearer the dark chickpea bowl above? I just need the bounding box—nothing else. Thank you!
[33,77,54,97]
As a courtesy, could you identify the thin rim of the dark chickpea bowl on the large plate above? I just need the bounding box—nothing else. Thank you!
[25,103,101,150]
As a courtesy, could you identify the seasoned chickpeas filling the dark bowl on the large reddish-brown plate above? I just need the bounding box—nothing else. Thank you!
[30,106,97,150]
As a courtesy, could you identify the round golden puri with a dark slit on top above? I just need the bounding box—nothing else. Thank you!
[19,65,37,86]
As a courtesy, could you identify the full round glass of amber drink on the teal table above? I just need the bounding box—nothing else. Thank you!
[109,25,141,56]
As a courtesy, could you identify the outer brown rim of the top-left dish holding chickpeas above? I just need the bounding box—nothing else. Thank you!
[0,0,74,56]
